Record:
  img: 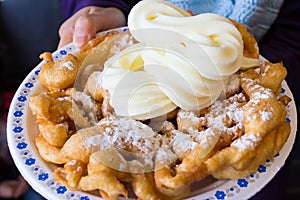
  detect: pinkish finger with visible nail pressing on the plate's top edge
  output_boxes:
[73,15,97,47]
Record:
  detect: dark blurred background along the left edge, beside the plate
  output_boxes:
[0,0,63,200]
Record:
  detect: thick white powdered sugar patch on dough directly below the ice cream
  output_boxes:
[85,118,181,170]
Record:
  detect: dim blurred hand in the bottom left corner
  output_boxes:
[0,176,29,198]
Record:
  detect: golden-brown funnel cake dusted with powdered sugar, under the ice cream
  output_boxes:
[30,12,291,199]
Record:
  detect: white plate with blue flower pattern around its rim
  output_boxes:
[7,27,297,200]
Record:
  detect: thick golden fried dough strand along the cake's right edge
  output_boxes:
[206,62,290,179]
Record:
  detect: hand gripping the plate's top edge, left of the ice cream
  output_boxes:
[58,6,126,48]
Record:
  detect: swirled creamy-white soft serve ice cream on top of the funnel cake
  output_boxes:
[101,0,258,120]
